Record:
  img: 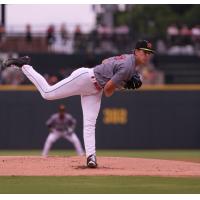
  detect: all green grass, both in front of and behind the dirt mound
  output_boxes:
[0,150,200,194]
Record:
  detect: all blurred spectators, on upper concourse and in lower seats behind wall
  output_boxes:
[0,21,200,85]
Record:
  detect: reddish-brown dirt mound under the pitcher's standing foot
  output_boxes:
[0,156,200,177]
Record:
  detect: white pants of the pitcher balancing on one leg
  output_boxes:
[22,65,103,157]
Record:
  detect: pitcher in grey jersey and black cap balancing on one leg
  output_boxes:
[3,40,154,168]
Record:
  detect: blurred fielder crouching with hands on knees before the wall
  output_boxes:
[42,104,84,156]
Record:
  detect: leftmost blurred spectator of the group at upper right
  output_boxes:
[167,24,179,46]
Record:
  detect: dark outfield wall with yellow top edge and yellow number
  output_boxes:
[0,85,200,149]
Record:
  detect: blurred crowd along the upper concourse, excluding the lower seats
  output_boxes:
[0,24,200,55]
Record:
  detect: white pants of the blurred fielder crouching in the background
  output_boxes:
[42,130,84,156]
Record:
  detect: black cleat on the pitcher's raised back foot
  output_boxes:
[2,56,31,69]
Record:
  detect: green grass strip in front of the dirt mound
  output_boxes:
[0,176,200,194]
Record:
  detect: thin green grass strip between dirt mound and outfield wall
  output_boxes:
[0,149,200,162]
